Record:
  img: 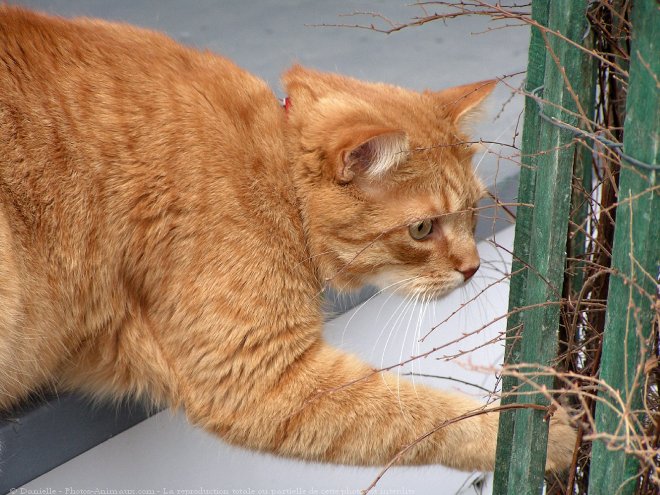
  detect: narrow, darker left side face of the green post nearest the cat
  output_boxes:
[493,0,550,494]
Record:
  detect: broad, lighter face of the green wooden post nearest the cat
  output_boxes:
[507,0,590,495]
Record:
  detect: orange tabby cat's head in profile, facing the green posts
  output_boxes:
[284,67,495,297]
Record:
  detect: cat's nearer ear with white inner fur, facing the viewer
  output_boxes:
[335,126,408,184]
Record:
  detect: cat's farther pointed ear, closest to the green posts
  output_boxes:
[433,79,497,125]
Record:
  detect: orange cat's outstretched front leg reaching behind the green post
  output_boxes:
[178,341,575,470]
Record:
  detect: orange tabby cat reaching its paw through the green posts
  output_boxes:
[0,6,574,470]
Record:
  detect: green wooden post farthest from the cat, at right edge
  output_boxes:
[589,0,660,495]
